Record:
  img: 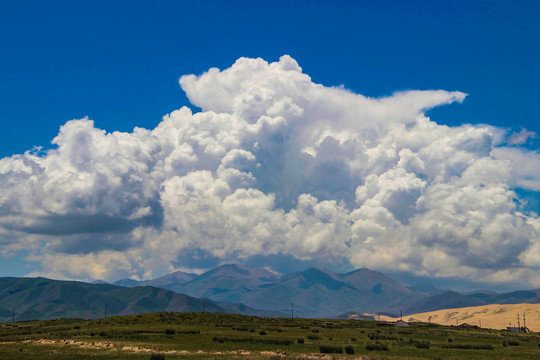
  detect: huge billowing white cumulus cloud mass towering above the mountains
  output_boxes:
[0,56,540,286]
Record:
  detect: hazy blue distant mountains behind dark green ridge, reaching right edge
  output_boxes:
[115,264,540,317]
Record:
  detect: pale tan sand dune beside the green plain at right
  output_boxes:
[381,304,540,332]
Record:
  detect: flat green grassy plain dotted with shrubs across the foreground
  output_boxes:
[0,313,540,360]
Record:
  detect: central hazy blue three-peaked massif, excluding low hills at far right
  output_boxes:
[124,264,425,317]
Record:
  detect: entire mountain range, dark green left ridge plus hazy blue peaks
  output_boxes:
[0,264,540,321]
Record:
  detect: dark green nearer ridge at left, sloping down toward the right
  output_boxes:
[0,278,282,321]
